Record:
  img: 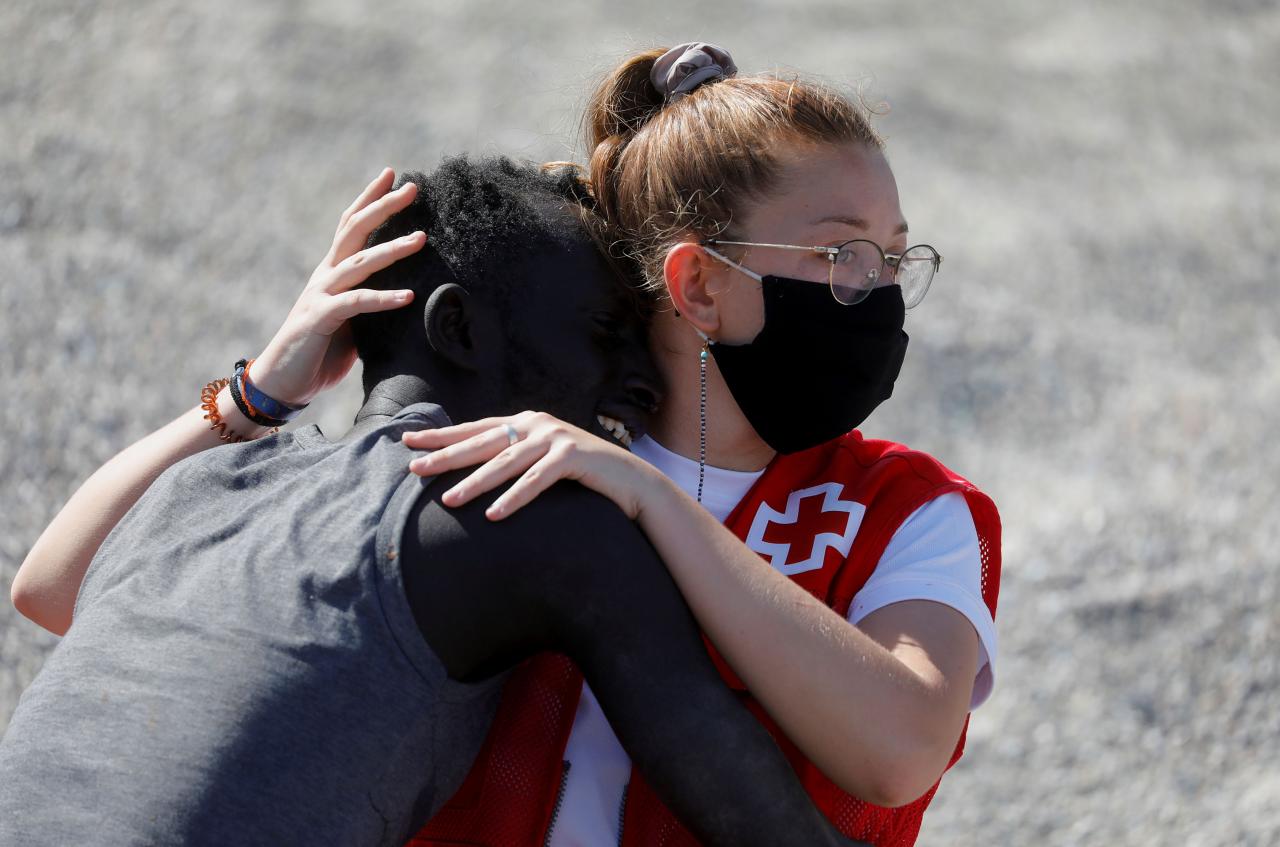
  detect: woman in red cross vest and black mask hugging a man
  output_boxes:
[15,44,1000,844]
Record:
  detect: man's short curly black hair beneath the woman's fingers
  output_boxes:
[352,156,611,368]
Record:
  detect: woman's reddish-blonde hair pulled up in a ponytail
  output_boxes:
[585,49,883,290]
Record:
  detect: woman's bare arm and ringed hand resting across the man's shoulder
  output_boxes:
[404,413,978,806]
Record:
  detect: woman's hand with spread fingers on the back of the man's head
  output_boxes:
[252,168,426,406]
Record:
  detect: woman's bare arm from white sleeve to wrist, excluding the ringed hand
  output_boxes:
[629,479,978,806]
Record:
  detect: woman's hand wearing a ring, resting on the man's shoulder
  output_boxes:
[403,412,666,521]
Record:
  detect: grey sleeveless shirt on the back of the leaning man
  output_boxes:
[0,403,502,846]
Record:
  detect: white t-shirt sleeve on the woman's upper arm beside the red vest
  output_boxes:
[849,493,996,709]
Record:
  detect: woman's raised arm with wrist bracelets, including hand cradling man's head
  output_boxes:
[10,169,426,635]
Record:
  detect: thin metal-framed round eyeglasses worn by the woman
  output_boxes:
[703,238,942,308]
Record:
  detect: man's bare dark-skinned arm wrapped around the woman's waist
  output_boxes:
[403,476,870,846]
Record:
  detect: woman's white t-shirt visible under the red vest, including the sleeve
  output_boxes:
[549,436,996,847]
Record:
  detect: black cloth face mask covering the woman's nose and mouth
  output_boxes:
[710,275,908,453]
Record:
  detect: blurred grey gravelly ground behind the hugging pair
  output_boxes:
[0,0,1280,844]
